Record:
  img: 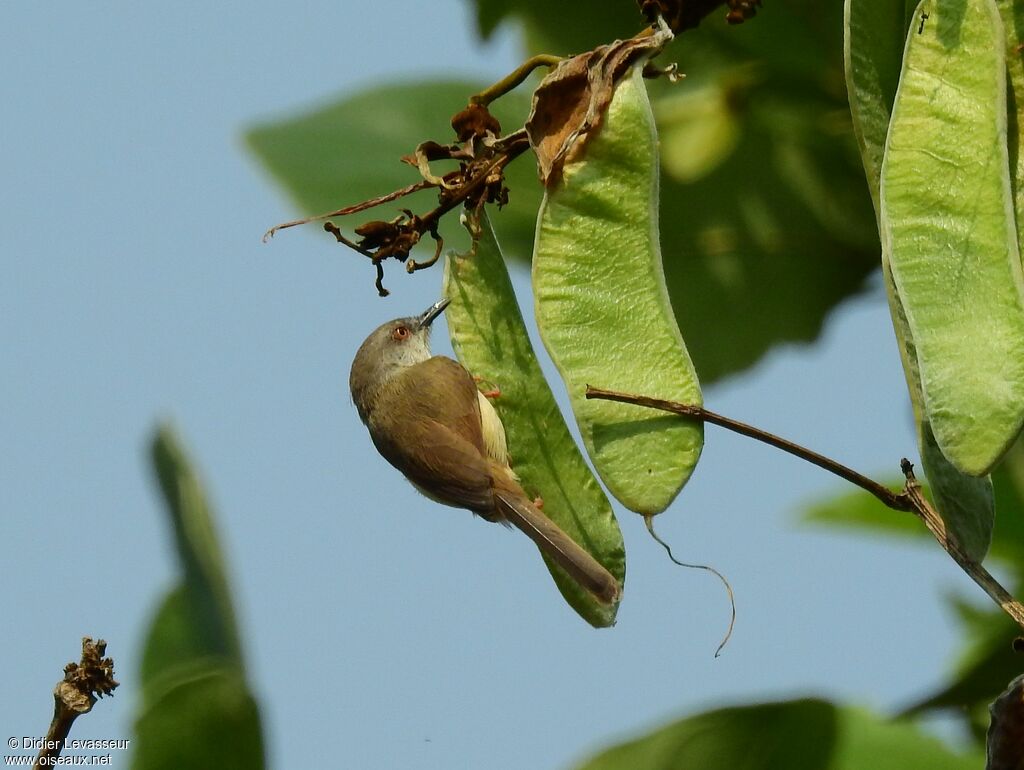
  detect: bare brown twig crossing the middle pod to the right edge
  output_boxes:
[586,385,1024,629]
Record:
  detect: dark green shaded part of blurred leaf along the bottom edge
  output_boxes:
[577,699,838,770]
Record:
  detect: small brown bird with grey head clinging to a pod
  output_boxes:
[349,299,622,604]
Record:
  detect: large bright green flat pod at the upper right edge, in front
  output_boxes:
[880,0,1024,476]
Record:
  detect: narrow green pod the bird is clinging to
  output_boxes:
[443,217,626,628]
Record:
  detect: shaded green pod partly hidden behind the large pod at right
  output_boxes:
[845,0,995,561]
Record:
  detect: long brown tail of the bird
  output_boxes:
[495,489,623,604]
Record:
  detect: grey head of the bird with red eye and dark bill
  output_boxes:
[348,299,451,420]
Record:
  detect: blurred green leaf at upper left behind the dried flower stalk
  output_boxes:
[246,81,541,262]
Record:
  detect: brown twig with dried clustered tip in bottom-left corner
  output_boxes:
[34,637,118,770]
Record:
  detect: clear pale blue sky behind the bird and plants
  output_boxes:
[0,0,976,770]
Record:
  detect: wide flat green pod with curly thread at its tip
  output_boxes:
[534,66,703,515]
